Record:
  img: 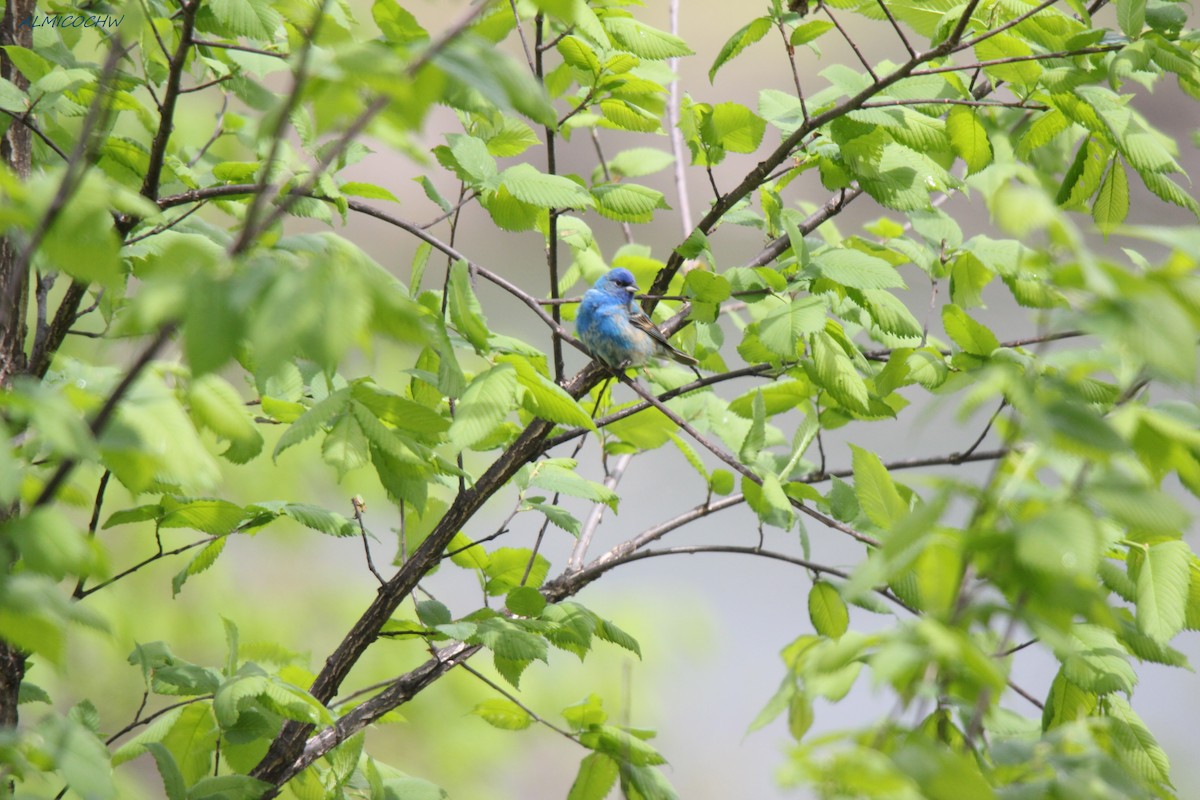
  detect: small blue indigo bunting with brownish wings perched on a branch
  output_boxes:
[575,266,698,369]
